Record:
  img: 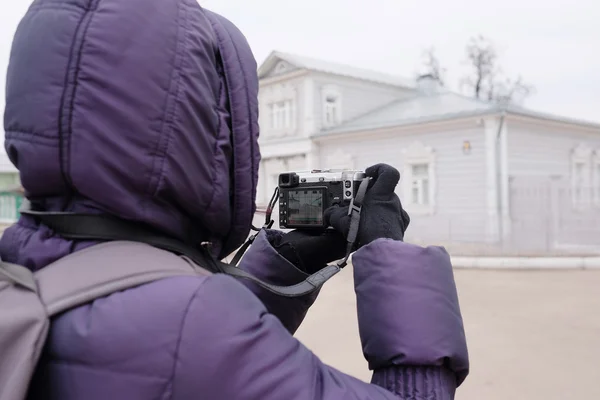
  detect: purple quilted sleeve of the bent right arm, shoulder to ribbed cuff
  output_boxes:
[173,240,468,400]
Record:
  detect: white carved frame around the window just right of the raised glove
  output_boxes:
[402,142,437,215]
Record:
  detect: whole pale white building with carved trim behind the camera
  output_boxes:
[257,52,600,254]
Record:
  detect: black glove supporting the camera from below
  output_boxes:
[271,229,346,274]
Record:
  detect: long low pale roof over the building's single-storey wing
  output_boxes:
[315,91,600,136]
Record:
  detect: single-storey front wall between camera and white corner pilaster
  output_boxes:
[319,119,488,243]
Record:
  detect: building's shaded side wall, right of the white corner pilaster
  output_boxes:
[507,117,600,253]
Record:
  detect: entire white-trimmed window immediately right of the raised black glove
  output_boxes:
[402,142,436,214]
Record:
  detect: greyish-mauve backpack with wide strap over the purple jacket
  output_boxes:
[0,241,210,400]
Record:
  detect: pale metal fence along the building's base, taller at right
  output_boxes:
[407,179,600,256]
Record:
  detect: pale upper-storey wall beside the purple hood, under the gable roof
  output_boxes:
[257,71,412,205]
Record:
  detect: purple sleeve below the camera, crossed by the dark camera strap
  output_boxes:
[239,230,318,334]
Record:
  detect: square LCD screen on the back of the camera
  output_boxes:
[288,189,323,225]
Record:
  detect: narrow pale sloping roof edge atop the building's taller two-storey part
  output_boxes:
[258,51,415,88]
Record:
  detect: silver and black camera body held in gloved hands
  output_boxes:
[278,169,365,229]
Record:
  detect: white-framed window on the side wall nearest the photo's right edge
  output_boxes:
[571,144,592,208]
